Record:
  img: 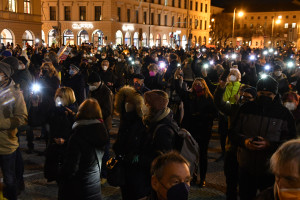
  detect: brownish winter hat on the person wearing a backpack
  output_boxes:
[144,90,169,111]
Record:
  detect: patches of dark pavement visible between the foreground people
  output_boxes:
[19,121,225,200]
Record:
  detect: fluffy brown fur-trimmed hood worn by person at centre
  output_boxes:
[115,85,145,117]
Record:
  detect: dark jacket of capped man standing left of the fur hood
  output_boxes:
[89,82,113,131]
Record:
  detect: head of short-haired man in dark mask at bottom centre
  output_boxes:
[151,151,191,200]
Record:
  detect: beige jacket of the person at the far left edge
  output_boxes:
[0,81,27,155]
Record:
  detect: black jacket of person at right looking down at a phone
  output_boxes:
[230,101,296,175]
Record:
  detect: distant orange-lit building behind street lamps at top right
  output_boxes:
[235,11,300,48]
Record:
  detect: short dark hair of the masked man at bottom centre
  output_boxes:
[151,151,190,180]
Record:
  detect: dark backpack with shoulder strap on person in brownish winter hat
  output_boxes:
[153,124,199,176]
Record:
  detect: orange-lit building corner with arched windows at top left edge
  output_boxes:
[0,0,42,46]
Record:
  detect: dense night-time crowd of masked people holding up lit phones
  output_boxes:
[0,41,300,200]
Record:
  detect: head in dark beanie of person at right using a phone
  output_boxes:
[256,76,278,102]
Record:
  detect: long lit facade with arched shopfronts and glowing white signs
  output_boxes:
[41,0,211,47]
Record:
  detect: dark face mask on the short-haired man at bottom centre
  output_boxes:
[167,183,190,200]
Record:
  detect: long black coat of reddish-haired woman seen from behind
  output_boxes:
[58,120,109,200]
